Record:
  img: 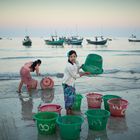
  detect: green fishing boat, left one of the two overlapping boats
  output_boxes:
[44,36,64,45]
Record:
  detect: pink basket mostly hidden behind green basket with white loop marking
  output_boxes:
[38,104,62,114]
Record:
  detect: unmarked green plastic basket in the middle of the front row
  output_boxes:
[56,115,84,140]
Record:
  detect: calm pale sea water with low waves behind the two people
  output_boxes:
[0,38,140,94]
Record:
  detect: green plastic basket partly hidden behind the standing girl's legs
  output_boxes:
[72,94,83,111]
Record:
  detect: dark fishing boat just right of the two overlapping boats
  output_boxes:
[87,36,107,45]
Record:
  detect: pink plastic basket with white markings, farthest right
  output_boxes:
[108,98,128,117]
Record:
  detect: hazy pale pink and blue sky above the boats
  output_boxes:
[0,0,140,36]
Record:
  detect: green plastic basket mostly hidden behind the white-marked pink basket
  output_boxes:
[102,95,121,111]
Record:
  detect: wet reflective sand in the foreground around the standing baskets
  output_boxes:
[0,80,140,140]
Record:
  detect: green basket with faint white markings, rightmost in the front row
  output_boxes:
[85,109,110,131]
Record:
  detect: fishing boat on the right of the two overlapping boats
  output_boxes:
[65,36,83,45]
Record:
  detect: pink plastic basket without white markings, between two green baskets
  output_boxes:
[86,93,102,108]
